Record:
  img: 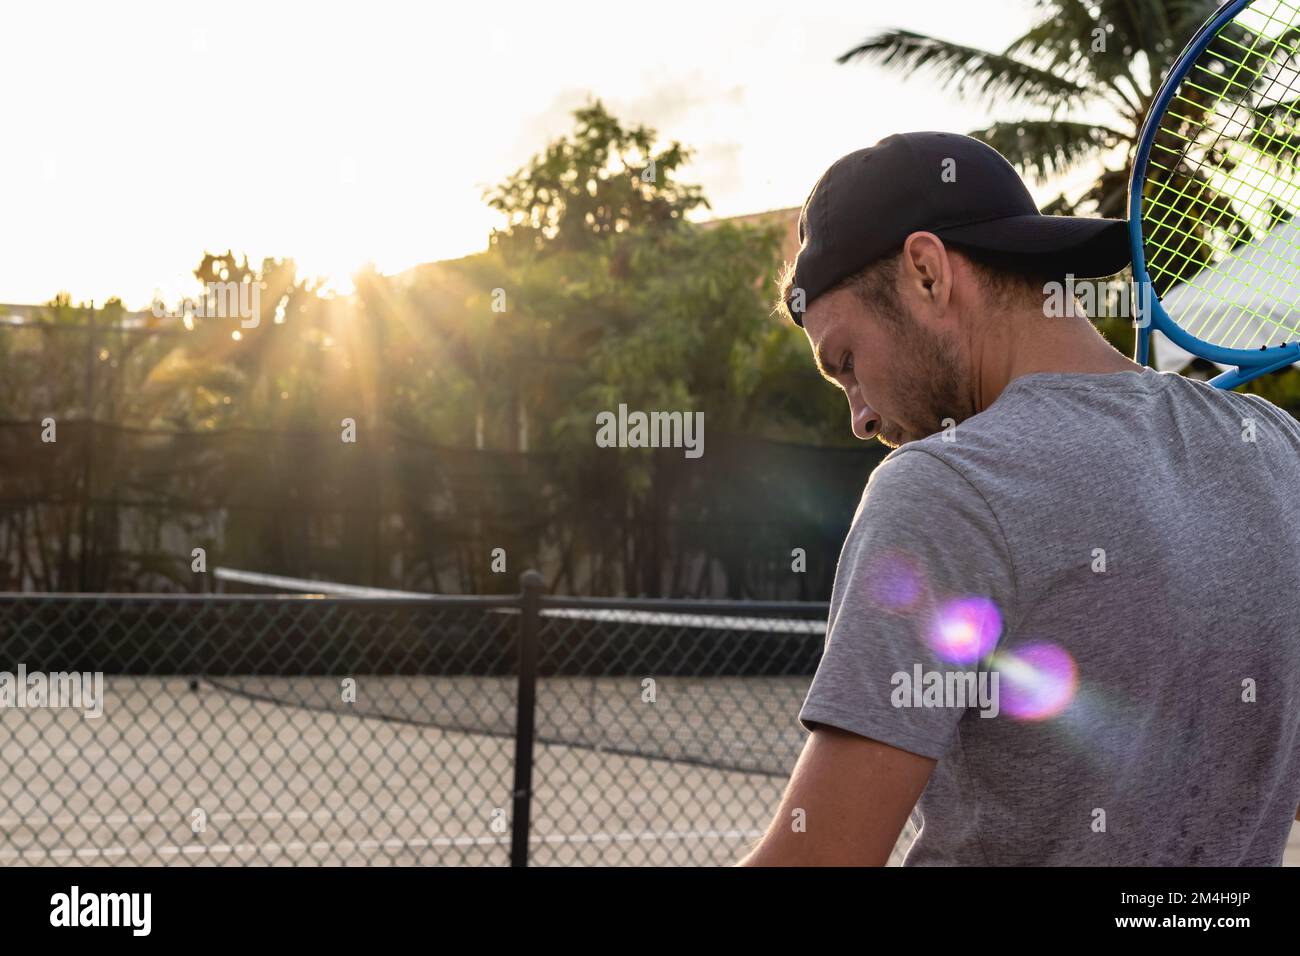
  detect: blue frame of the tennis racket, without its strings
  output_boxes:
[1128,0,1300,389]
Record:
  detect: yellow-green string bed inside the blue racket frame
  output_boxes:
[1143,0,1300,347]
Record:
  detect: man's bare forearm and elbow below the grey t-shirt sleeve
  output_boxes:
[736,726,936,866]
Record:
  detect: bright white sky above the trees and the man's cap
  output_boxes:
[0,0,1076,308]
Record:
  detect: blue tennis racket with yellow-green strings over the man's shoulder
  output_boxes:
[1128,0,1300,389]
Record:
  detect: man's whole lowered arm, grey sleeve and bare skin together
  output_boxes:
[742,446,1018,866]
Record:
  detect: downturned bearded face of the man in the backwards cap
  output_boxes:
[803,289,967,447]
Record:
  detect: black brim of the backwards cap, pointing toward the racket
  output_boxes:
[935,216,1131,278]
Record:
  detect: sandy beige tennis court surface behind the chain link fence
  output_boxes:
[0,678,857,865]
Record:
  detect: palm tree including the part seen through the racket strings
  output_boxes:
[839,0,1300,408]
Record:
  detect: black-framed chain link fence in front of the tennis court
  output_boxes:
[0,574,842,865]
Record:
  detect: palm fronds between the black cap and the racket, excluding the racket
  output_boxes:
[837,0,1218,219]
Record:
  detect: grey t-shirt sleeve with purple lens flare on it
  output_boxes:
[798,446,1015,760]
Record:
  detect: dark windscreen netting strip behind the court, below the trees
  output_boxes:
[0,420,884,600]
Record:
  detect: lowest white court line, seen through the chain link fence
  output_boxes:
[0,830,764,861]
